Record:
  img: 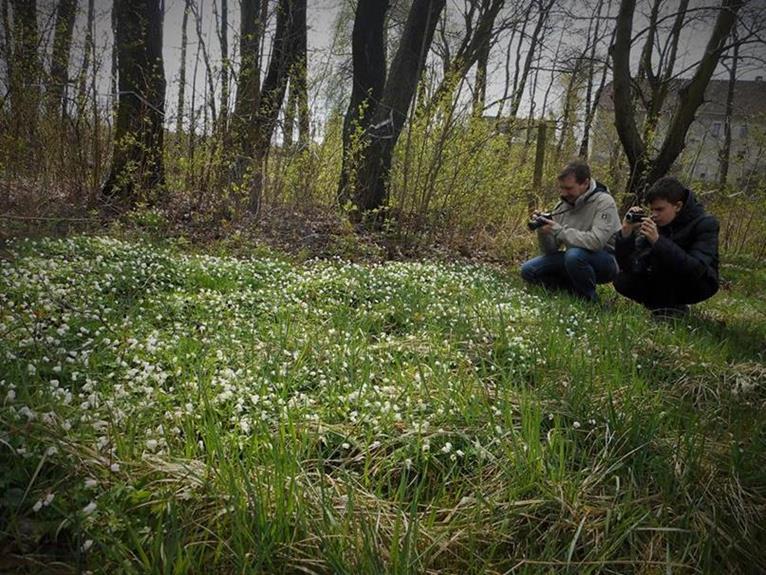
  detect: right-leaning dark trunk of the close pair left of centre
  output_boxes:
[249,0,306,213]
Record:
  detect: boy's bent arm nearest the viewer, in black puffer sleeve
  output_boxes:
[652,217,718,278]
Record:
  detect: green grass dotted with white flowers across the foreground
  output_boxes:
[0,237,766,574]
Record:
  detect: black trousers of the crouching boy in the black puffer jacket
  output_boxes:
[614,271,718,309]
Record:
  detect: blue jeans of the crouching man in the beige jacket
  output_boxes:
[521,248,618,301]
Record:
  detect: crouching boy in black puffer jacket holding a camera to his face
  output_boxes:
[614,177,718,315]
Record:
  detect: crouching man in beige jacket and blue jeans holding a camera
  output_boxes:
[521,160,620,302]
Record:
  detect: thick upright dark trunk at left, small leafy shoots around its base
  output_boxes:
[102,0,165,214]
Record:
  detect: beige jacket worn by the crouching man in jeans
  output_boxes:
[537,178,622,254]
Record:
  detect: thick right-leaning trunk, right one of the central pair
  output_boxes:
[354,0,445,220]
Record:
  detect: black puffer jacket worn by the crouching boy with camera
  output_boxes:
[615,190,718,285]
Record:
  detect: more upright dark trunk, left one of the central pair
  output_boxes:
[338,0,389,205]
